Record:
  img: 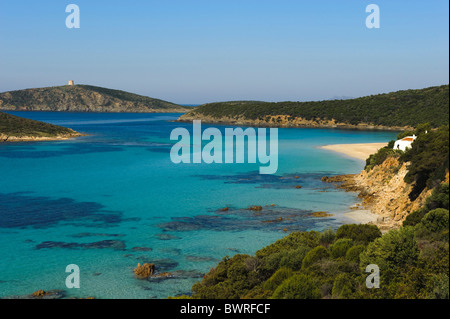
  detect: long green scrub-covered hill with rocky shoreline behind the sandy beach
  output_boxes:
[179,85,449,129]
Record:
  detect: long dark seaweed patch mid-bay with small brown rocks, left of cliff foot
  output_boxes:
[158,207,337,232]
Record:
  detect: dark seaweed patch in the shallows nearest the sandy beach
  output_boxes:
[194,171,338,189]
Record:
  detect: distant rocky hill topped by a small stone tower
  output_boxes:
[0,85,190,113]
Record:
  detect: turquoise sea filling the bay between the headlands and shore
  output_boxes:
[0,112,396,298]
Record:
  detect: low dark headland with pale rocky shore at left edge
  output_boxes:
[0,112,82,143]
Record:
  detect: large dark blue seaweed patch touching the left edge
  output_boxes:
[0,193,122,228]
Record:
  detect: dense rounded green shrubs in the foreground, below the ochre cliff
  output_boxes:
[176,209,449,299]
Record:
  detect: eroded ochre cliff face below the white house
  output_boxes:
[323,157,448,230]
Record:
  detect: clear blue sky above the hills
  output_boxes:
[0,0,449,104]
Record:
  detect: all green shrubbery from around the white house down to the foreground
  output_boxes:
[179,124,449,299]
